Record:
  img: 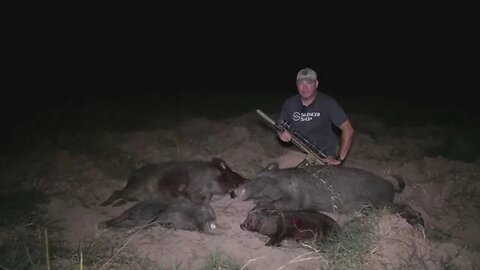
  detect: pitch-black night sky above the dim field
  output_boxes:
[2,8,477,123]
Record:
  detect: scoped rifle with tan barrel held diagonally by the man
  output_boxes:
[257,110,327,168]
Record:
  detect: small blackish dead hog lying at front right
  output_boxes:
[240,208,340,246]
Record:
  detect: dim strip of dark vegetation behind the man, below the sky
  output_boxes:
[2,90,480,161]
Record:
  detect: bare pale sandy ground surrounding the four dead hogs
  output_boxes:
[41,114,480,270]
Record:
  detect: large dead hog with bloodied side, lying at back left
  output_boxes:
[101,158,247,206]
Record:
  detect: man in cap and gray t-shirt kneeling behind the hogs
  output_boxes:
[278,68,354,167]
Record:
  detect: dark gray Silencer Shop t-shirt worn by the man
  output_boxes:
[279,92,348,156]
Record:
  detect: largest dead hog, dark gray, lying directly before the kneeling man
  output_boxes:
[240,165,423,225]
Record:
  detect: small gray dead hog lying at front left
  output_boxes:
[98,198,216,233]
